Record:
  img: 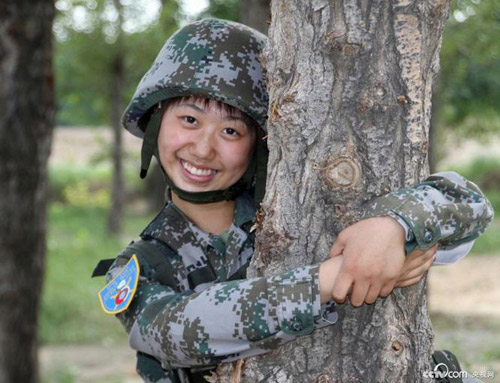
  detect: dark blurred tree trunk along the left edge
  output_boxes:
[0,0,54,383]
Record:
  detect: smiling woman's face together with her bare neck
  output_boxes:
[158,97,258,234]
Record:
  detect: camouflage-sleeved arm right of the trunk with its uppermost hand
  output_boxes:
[330,172,493,306]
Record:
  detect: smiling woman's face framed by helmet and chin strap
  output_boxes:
[158,97,256,192]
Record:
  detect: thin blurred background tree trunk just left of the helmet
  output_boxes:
[108,0,124,234]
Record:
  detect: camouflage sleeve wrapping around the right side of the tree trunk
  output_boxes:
[364,172,493,263]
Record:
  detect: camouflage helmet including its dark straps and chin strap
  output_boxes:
[126,19,268,203]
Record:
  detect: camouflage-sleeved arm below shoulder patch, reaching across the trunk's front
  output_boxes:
[110,250,341,367]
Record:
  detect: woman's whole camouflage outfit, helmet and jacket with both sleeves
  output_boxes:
[98,20,492,383]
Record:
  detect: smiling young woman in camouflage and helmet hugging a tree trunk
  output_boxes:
[94,19,496,383]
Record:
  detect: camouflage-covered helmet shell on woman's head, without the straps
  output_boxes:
[122,19,268,137]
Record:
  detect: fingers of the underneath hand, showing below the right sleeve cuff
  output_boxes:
[394,244,438,287]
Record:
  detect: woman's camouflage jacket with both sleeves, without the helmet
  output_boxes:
[108,173,493,383]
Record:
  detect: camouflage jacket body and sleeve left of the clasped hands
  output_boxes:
[107,194,337,382]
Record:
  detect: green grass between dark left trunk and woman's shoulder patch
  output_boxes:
[40,204,150,344]
